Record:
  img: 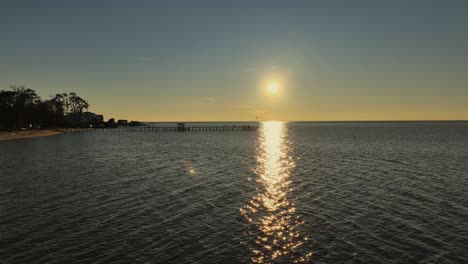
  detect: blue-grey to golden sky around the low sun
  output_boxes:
[0,0,468,121]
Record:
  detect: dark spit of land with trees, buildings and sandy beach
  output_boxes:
[0,85,140,135]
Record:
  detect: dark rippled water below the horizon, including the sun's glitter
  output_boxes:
[0,123,468,263]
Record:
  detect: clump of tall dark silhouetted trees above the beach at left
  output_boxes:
[0,85,89,129]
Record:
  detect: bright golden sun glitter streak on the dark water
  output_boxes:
[240,122,312,263]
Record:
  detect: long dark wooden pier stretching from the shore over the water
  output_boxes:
[94,123,258,132]
